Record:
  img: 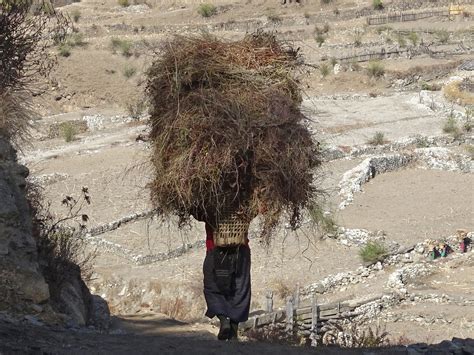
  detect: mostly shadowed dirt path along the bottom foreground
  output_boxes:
[0,316,474,355]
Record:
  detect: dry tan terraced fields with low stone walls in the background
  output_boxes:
[0,0,474,354]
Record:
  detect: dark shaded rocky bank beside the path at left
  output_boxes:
[0,137,109,328]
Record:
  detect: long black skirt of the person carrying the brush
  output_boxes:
[203,246,251,322]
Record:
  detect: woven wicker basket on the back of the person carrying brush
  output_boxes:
[214,212,250,247]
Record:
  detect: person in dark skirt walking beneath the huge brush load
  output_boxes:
[194,211,251,340]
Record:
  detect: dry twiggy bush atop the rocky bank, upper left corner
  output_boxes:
[0,0,68,142]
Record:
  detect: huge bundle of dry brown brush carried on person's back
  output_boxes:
[147,33,320,242]
